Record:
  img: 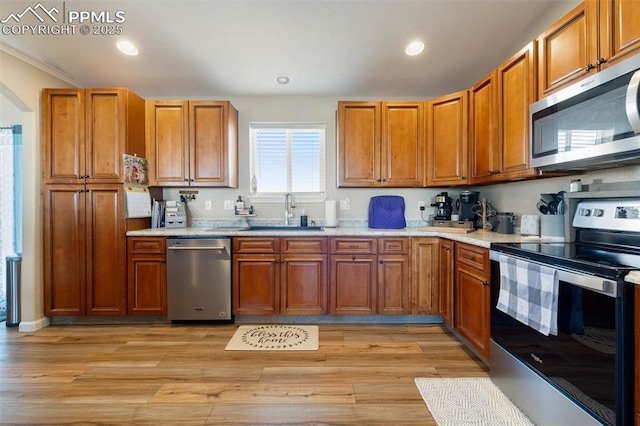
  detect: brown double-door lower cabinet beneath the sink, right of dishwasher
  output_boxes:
[233,237,328,315]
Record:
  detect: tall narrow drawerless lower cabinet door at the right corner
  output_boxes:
[411,237,438,315]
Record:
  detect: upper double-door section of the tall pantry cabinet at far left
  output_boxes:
[42,88,145,184]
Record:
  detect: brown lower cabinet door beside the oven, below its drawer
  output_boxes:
[454,266,490,358]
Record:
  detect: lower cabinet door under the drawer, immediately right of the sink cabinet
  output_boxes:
[329,254,377,315]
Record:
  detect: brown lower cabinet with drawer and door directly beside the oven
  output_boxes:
[453,243,491,359]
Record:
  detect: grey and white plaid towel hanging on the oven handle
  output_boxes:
[496,255,559,336]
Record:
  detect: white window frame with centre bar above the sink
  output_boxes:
[249,122,327,203]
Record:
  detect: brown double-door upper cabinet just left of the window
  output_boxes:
[147,101,238,188]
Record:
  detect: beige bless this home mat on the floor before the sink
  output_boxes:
[225,325,318,351]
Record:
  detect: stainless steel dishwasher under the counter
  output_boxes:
[167,237,232,321]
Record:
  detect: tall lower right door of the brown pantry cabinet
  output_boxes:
[86,185,127,315]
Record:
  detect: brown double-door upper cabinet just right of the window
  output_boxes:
[338,101,424,187]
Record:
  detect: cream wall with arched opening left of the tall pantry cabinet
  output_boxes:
[0,51,70,331]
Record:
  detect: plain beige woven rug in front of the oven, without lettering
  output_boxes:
[415,378,533,426]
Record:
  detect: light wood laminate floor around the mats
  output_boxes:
[0,324,488,425]
